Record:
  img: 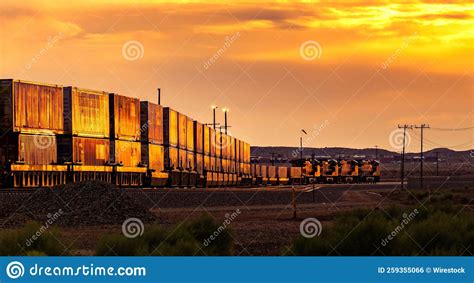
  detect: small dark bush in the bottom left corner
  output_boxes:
[0,222,67,256]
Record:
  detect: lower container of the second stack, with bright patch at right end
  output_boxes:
[57,136,110,166]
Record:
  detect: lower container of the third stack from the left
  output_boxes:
[110,140,141,167]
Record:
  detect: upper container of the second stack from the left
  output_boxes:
[64,87,110,138]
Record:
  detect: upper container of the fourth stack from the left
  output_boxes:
[140,101,163,145]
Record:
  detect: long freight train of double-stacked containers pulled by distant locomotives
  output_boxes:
[0,79,380,188]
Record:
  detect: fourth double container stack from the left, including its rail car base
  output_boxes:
[140,101,168,187]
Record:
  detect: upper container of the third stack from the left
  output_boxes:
[109,93,140,141]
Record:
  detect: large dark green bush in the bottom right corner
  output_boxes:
[286,206,474,256]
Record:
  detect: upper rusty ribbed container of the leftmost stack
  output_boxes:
[0,79,64,135]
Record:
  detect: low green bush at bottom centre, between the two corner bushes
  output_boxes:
[96,215,233,256]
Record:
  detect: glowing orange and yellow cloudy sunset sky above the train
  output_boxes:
[0,0,474,151]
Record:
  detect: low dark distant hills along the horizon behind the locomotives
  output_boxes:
[251,146,474,162]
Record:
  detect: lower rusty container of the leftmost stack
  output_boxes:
[0,133,58,165]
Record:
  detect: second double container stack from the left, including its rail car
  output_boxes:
[58,87,112,182]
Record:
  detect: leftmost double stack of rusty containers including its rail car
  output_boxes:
[0,79,66,187]
